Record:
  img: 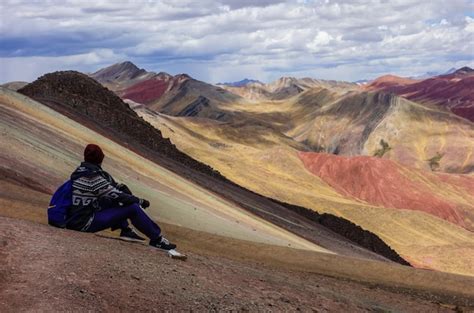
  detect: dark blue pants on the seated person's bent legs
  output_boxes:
[87,204,161,240]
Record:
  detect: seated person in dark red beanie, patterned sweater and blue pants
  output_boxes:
[66,144,176,250]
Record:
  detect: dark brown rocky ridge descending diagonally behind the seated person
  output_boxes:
[13,72,406,264]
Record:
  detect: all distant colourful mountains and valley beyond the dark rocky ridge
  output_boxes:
[83,61,474,273]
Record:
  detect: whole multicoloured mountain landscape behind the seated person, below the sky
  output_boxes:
[0,62,474,305]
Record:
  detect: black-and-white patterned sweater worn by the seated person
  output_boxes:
[67,162,140,231]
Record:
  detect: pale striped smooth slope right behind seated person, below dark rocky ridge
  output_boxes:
[0,88,325,251]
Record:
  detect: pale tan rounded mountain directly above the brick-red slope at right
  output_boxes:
[287,92,474,173]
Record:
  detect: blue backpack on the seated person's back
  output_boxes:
[48,180,72,228]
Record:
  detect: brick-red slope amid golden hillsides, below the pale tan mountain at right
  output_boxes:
[299,152,474,229]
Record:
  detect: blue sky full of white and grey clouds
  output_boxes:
[0,0,474,83]
